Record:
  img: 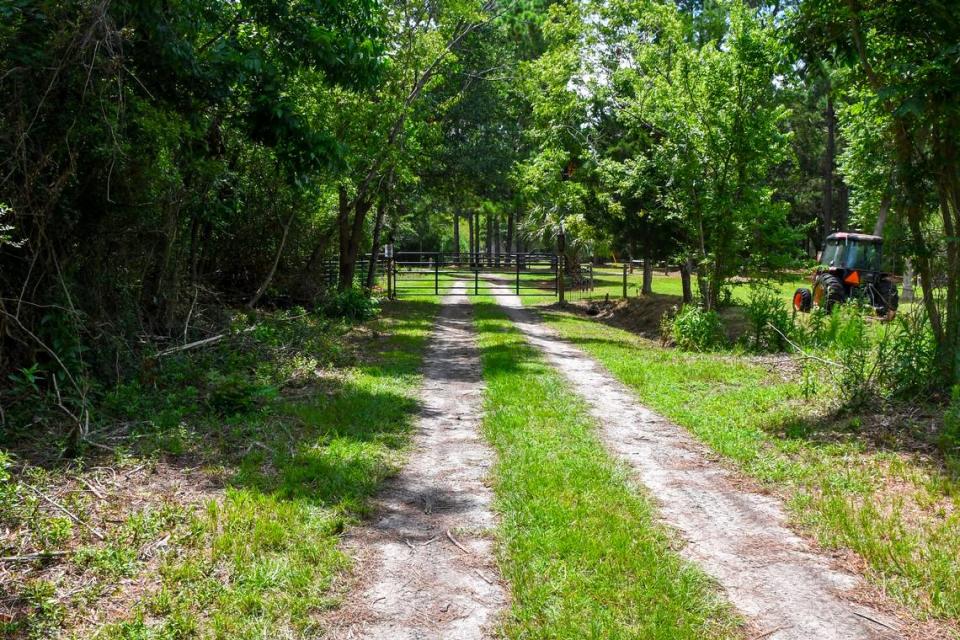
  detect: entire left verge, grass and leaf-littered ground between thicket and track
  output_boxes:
[0,301,437,639]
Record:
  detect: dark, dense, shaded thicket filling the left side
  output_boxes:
[0,0,383,440]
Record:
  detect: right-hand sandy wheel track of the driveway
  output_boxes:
[497,292,908,640]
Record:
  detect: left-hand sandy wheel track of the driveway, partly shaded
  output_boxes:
[324,283,507,640]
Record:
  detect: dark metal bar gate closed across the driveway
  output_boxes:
[387,251,558,297]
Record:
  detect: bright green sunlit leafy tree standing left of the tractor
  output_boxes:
[604,2,796,309]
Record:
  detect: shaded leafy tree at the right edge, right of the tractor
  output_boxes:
[794,0,960,381]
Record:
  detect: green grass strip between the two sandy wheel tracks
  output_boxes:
[475,302,738,640]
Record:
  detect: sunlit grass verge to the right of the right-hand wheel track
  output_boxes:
[541,310,960,622]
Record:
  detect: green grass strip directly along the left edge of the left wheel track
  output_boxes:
[93,302,436,639]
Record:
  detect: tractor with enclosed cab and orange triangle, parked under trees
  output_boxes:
[793,233,900,320]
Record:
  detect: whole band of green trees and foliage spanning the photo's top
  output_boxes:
[0,0,960,416]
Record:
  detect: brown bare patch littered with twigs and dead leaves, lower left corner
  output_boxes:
[0,461,222,637]
